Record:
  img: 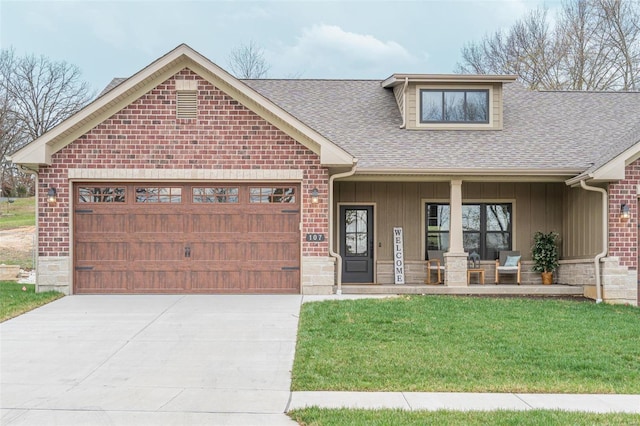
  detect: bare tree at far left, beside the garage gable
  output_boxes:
[0,49,93,196]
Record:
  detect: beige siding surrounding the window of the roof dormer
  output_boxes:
[404,83,502,130]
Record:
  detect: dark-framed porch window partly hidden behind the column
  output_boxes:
[425,203,512,260]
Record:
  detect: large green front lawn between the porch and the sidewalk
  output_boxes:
[292,296,640,394]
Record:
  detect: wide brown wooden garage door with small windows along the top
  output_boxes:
[73,183,300,294]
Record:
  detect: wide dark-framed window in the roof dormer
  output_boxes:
[420,89,489,123]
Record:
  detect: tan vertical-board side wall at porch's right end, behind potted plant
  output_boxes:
[562,188,602,259]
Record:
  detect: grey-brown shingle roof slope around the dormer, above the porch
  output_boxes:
[244,80,640,174]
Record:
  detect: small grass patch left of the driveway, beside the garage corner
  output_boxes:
[0,281,63,322]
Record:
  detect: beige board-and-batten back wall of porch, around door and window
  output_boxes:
[334,182,566,262]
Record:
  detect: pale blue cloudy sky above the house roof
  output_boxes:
[0,0,560,91]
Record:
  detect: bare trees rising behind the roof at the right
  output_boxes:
[457,0,640,90]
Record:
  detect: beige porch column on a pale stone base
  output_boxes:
[444,180,467,287]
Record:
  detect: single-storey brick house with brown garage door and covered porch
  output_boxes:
[12,45,640,305]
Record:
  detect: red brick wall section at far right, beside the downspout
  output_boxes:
[609,160,640,269]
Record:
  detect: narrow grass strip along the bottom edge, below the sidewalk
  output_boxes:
[287,407,640,426]
